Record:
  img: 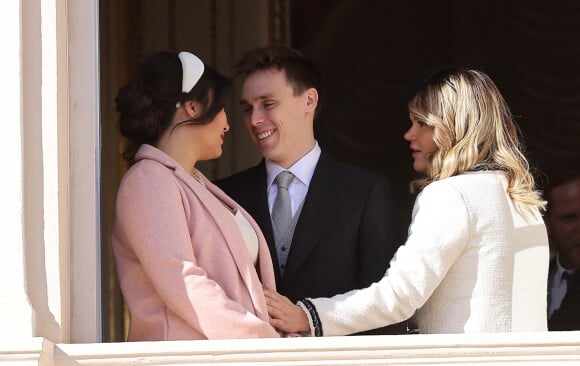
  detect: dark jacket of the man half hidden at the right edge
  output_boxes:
[548,258,580,331]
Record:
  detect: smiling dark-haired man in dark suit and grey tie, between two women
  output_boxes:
[216,47,406,334]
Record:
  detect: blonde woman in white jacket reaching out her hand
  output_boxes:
[266,69,549,336]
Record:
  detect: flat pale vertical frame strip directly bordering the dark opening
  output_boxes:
[65,0,101,343]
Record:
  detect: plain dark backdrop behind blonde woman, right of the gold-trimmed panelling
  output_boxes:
[291,0,580,229]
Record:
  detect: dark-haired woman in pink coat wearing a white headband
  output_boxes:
[113,52,279,341]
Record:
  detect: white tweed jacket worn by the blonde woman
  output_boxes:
[310,171,549,336]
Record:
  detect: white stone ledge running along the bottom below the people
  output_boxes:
[49,332,580,366]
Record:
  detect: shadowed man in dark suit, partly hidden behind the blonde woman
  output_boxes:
[545,159,580,330]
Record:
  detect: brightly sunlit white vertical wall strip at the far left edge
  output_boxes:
[0,1,33,343]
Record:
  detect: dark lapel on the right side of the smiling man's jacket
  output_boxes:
[284,152,348,278]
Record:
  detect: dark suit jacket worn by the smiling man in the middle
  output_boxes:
[216,151,401,334]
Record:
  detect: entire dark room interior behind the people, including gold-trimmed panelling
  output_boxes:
[99,0,580,341]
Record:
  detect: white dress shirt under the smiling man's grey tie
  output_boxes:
[266,142,321,217]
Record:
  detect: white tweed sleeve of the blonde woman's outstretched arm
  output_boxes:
[311,183,469,336]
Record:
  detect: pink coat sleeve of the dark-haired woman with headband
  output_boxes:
[117,164,278,339]
